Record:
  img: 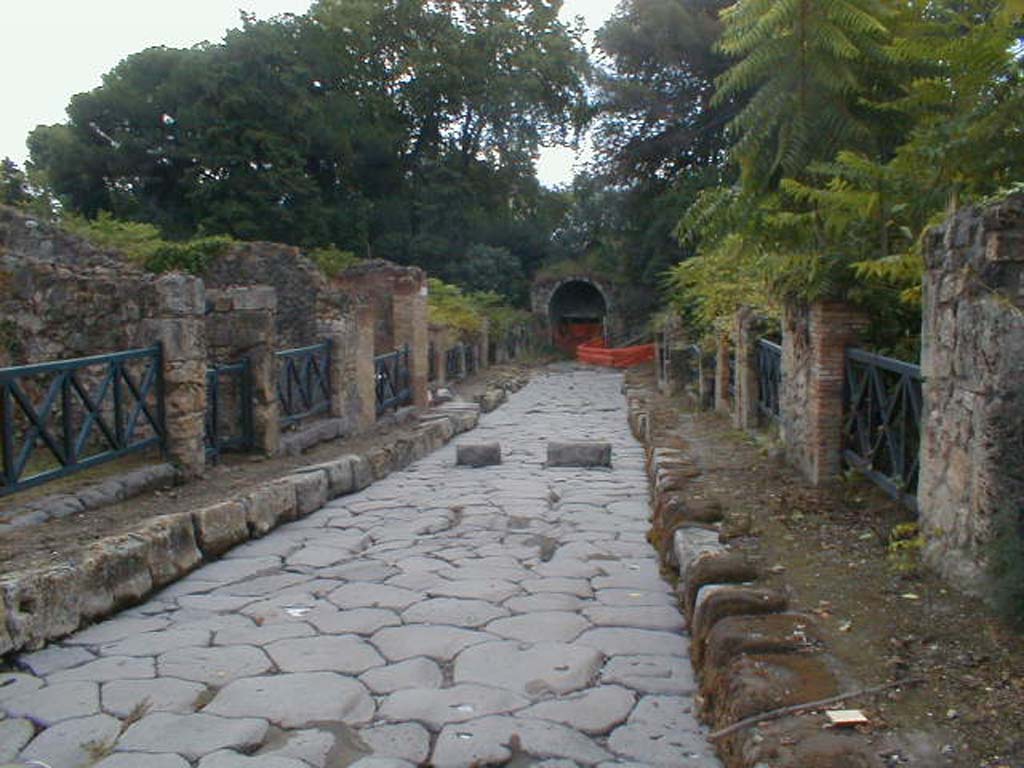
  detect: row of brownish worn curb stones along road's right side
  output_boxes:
[623,372,882,768]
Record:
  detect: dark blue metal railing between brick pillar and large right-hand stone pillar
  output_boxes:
[843,349,922,507]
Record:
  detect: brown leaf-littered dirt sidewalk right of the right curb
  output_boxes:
[656,380,1024,768]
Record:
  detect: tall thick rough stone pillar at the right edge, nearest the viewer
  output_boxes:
[918,195,1024,591]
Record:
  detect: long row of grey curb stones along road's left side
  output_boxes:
[0,402,497,656]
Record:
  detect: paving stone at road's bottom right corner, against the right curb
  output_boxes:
[608,696,721,768]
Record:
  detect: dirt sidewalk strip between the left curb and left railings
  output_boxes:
[0,366,522,575]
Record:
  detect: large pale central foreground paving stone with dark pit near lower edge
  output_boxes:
[455,640,604,696]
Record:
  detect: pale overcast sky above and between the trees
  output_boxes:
[0,0,617,185]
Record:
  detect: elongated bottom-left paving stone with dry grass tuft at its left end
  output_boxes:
[118,712,267,760]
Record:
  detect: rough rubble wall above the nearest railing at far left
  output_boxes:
[0,207,159,367]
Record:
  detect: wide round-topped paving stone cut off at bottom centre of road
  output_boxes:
[431,716,610,768]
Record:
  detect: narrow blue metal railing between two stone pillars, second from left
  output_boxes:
[204,357,253,461]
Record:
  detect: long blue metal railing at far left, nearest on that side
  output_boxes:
[0,345,165,496]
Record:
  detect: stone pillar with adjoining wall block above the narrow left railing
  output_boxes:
[206,286,281,456]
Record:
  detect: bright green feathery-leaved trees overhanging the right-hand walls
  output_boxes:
[668,0,1024,357]
